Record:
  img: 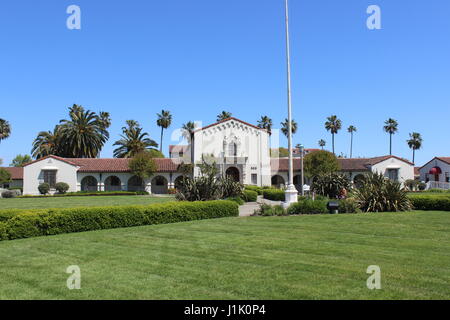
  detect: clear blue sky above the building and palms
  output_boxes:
[0,0,450,165]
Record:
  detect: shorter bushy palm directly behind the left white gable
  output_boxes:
[31,126,66,159]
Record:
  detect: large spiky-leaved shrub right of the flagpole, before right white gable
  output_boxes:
[354,173,412,212]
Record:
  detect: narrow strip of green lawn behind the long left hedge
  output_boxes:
[0,196,174,209]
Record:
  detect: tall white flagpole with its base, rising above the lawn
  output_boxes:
[285,0,298,207]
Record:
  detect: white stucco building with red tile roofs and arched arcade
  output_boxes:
[19,118,414,195]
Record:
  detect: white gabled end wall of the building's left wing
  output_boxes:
[23,158,78,195]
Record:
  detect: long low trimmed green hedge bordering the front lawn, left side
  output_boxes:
[0,200,239,240]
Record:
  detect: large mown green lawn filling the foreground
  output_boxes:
[0,212,450,299]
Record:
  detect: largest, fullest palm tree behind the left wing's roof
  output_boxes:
[60,105,109,158]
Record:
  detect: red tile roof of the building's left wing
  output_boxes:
[23,156,180,172]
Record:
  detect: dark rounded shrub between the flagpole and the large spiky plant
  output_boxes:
[311,173,350,199]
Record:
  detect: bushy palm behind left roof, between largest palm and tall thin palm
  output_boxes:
[114,120,158,158]
